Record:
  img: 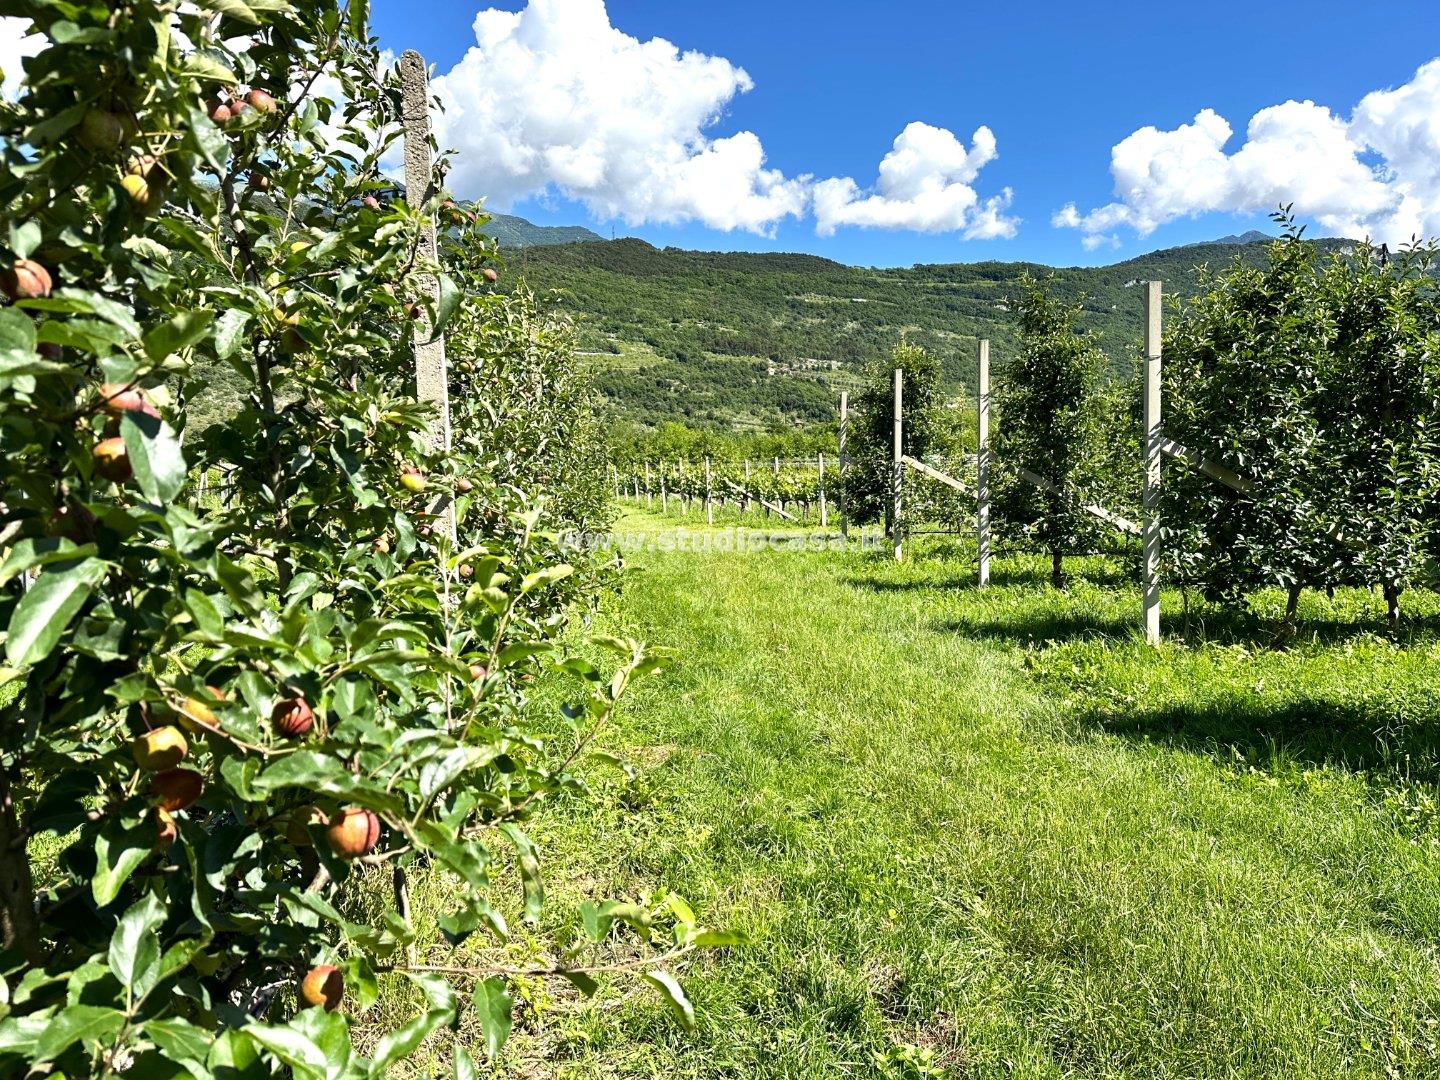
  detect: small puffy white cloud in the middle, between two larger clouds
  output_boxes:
[815,122,1018,239]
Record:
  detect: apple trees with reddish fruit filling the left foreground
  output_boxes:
[0,0,726,1077]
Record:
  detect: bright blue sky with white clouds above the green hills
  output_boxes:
[373,0,1440,265]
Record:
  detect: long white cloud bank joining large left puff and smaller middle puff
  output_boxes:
[420,0,1015,238]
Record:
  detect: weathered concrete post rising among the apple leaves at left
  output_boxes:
[400,49,455,546]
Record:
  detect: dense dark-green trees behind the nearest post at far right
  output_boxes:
[1164,217,1440,624]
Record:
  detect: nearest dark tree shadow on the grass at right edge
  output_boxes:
[1076,698,1440,783]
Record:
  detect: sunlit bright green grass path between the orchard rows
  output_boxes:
[514,521,1440,1079]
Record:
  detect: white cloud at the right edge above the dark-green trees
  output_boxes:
[1051,60,1440,248]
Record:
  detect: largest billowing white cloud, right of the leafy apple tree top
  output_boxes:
[433,0,809,233]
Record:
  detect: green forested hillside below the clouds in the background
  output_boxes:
[510,236,1341,426]
